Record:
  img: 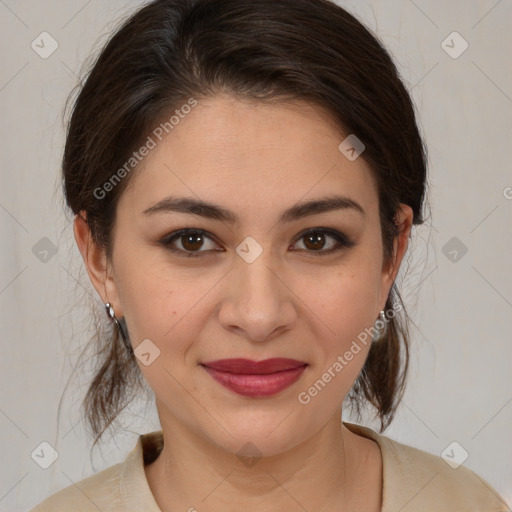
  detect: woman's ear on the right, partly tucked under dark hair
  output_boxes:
[380,203,414,310]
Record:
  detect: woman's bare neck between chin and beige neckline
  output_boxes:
[145,411,378,512]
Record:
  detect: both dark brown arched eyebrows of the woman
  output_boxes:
[142,195,366,224]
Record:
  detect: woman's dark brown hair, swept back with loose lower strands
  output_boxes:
[63,0,426,443]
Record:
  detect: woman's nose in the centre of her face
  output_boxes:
[218,255,297,342]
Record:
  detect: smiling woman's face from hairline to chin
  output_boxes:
[83,96,412,455]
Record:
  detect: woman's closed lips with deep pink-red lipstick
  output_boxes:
[201,358,308,398]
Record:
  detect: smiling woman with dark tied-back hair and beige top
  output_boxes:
[34,0,508,512]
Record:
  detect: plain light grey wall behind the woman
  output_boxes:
[0,0,512,511]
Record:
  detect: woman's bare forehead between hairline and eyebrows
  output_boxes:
[120,96,377,218]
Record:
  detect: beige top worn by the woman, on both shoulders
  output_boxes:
[30,422,511,512]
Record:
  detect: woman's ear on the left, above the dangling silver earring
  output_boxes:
[73,210,122,318]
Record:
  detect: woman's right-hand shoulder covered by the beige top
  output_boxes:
[345,423,510,512]
